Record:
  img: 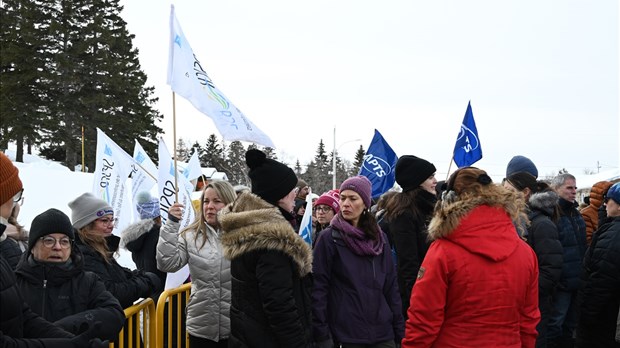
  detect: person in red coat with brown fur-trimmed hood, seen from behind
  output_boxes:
[402,167,540,348]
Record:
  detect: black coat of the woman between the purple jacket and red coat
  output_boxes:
[382,189,437,319]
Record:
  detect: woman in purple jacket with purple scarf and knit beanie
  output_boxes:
[312,176,404,348]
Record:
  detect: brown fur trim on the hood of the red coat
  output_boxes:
[428,184,528,240]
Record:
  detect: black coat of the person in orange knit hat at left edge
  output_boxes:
[0,238,73,348]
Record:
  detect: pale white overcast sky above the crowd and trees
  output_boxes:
[118,0,620,185]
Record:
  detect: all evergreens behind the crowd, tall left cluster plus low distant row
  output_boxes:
[0,0,364,194]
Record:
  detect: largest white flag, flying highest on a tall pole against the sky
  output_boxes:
[167,5,275,148]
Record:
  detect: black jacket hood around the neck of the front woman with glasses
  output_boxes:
[15,245,84,285]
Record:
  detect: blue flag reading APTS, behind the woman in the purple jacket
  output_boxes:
[358,129,398,198]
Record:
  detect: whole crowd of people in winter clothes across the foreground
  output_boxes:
[0,149,620,348]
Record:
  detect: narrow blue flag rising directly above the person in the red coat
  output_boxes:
[453,102,482,168]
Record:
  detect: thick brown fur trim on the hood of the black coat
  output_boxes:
[218,192,312,277]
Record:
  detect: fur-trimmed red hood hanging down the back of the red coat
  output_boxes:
[428,194,525,262]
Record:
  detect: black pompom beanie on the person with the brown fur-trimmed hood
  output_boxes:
[245,149,297,205]
